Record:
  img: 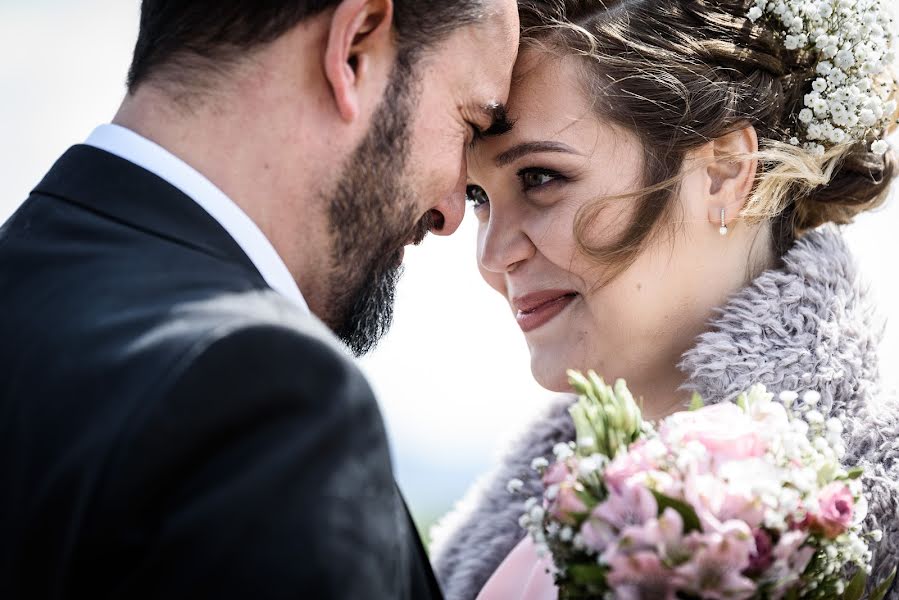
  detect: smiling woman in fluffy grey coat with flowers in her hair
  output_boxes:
[434,0,899,600]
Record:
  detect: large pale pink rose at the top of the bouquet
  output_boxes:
[659,403,766,462]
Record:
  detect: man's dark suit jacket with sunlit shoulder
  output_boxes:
[0,146,440,600]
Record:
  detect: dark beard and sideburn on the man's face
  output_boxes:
[324,59,432,356]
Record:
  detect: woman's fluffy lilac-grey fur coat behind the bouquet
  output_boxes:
[433,228,899,600]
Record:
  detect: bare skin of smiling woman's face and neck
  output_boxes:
[467,51,760,391]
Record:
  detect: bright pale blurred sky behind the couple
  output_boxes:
[0,0,899,536]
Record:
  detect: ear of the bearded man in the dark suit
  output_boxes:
[324,0,394,122]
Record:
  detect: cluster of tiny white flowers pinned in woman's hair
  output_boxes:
[749,0,897,156]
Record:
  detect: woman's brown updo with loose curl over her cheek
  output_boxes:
[519,0,896,272]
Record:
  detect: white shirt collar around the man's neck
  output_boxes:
[85,125,309,312]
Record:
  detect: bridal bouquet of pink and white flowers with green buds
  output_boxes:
[510,372,895,600]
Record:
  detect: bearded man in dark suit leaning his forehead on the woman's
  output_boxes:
[0,0,518,600]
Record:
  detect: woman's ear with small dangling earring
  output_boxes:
[704,125,759,225]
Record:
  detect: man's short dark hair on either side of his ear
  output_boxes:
[128,0,483,93]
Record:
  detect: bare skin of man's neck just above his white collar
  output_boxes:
[113,87,330,312]
